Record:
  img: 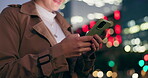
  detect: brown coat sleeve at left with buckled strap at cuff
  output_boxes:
[0,7,68,78]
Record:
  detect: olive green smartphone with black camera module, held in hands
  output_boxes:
[86,19,112,36]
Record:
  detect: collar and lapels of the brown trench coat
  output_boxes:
[20,0,70,46]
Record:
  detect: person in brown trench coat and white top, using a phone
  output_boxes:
[0,0,102,78]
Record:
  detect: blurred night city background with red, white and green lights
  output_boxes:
[0,0,148,78]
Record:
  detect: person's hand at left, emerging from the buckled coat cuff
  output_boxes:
[53,34,93,58]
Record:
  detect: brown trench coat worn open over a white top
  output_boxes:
[0,1,95,78]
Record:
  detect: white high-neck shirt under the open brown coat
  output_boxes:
[35,4,65,43]
